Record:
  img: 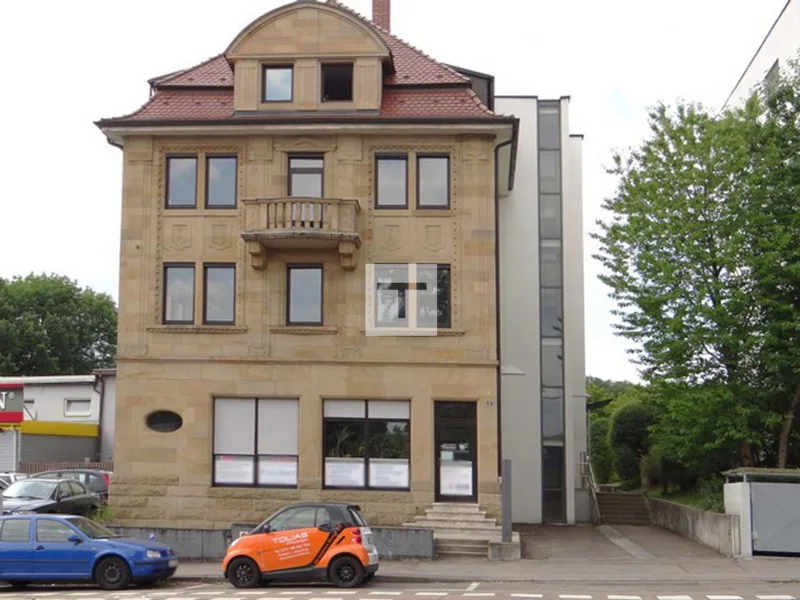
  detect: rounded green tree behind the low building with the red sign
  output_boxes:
[0,274,117,376]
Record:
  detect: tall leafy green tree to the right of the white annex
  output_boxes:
[595,51,800,476]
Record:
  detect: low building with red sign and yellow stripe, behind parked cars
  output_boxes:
[0,369,116,471]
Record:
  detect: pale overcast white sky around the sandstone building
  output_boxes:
[0,0,785,381]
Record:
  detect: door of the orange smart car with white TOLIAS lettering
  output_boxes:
[260,506,330,571]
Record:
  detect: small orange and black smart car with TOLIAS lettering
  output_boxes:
[222,502,378,588]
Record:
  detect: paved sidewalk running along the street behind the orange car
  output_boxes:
[175,557,800,584]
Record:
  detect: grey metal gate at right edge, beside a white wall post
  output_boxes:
[750,482,800,553]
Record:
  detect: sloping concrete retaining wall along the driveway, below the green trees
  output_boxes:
[648,498,741,556]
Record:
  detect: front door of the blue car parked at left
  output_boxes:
[33,517,94,579]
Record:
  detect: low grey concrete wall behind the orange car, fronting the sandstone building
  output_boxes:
[109,523,436,560]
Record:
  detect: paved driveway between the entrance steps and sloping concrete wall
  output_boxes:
[514,524,722,561]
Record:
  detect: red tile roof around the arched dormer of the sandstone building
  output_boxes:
[101,0,506,123]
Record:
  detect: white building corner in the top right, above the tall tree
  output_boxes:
[724,0,800,108]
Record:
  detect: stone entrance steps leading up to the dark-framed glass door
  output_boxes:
[403,502,519,558]
